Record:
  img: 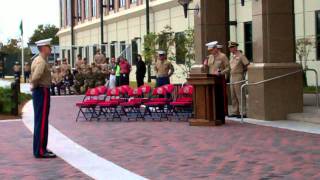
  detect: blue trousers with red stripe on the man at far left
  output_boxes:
[32,87,50,157]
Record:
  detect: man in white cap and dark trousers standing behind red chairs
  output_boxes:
[154,51,174,87]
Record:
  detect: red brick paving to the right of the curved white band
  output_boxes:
[50,97,320,180]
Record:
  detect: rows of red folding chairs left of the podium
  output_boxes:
[76,84,193,121]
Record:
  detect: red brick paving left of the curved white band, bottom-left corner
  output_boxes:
[0,122,90,179]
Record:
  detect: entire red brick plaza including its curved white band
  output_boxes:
[0,96,320,180]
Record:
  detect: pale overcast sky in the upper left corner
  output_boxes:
[0,0,59,44]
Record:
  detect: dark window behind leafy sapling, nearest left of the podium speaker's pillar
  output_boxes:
[175,32,187,64]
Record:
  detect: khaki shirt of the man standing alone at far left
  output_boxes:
[30,55,51,88]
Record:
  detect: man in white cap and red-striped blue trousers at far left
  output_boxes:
[30,39,56,158]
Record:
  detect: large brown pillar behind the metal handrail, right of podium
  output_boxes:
[248,0,303,120]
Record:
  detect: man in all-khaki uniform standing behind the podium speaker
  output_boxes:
[228,41,250,118]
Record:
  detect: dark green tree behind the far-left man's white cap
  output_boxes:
[29,24,59,45]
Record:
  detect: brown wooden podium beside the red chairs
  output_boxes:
[187,73,225,126]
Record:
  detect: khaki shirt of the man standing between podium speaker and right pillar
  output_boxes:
[230,52,250,74]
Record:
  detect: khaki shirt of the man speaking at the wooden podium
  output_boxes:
[208,53,230,75]
